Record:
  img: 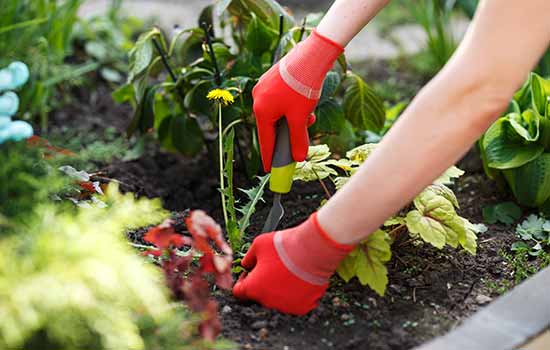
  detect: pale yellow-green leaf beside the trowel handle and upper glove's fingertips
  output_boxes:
[294,145,338,182]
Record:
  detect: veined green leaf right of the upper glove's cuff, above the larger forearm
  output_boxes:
[344,73,386,132]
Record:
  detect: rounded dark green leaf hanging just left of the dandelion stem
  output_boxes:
[170,116,203,156]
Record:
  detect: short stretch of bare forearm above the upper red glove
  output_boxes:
[317,0,390,47]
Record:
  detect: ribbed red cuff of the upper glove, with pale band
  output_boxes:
[279,30,344,100]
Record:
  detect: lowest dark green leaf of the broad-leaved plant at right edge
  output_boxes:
[504,153,550,207]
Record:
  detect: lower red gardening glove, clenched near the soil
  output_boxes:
[233,213,354,315]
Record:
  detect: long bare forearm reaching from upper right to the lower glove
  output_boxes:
[319,0,550,243]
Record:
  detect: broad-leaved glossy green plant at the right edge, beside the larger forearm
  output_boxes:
[478,73,550,212]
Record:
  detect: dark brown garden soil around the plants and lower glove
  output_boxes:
[51,69,528,350]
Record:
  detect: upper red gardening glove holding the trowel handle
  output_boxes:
[252,31,344,172]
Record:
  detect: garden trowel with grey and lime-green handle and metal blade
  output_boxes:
[262,116,296,232]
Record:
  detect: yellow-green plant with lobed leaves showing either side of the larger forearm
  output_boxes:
[295,144,484,295]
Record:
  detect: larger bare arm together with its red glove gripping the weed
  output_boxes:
[234,0,550,314]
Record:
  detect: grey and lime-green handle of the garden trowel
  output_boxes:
[269,117,296,193]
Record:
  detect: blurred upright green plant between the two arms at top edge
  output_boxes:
[407,0,458,72]
